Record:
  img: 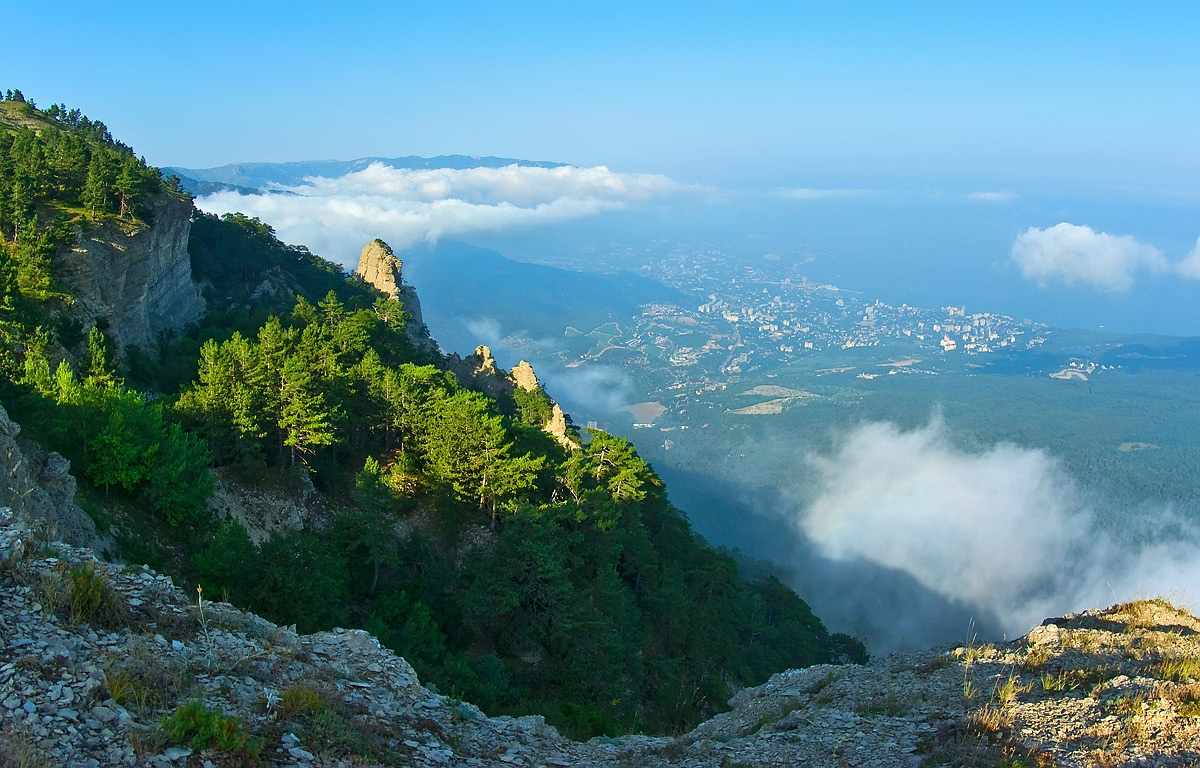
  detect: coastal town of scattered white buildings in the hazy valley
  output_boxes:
[552,244,1048,377]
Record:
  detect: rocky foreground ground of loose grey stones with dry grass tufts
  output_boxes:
[0,509,1200,768]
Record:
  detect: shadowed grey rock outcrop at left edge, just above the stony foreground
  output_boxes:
[0,407,102,548]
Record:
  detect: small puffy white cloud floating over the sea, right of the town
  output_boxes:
[1010,222,1170,292]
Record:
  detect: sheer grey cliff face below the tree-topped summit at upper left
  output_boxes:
[55,193,204,346]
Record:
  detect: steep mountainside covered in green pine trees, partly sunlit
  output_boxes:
[0,90,864,736]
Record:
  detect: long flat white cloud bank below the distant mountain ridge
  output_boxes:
[196,163,683,266]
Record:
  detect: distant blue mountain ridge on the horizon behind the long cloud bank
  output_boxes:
[162,155,568,194]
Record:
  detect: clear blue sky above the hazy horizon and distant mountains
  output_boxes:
[9,1,1200,192]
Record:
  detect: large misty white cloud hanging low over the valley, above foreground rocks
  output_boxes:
[794,418,1200,637]
